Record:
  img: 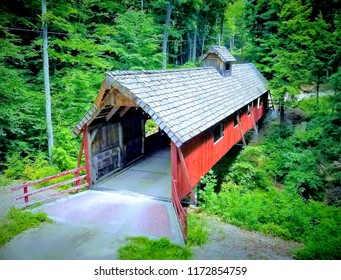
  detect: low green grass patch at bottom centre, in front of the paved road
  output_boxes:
[118,237,191,260]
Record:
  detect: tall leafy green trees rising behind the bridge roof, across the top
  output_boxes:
[0,0,340,178]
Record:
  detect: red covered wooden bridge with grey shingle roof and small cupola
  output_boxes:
[73,46,268,241]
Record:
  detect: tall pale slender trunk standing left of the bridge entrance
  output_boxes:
[41,0,54,164]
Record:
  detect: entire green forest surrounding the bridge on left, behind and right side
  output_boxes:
[0,0,341,259]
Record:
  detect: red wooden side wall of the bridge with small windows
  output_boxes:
[171,94,267,200]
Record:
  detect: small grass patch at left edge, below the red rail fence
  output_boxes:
[0,208,52,246]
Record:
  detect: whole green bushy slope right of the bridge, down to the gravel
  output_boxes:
[200,96,341,259]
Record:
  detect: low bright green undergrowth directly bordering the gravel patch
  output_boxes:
[202,171,341,259]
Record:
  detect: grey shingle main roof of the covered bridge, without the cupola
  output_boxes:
[73,64,268,147]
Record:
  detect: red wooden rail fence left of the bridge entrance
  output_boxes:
[11,166,89,207]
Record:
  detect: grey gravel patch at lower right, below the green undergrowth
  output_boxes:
[192,212,300,260]
